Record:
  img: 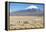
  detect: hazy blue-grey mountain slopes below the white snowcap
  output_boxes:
[10,8,44,16]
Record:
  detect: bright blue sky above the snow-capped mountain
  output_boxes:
[10,3,44,12]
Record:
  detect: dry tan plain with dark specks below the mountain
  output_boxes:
[10,16,43,30]
